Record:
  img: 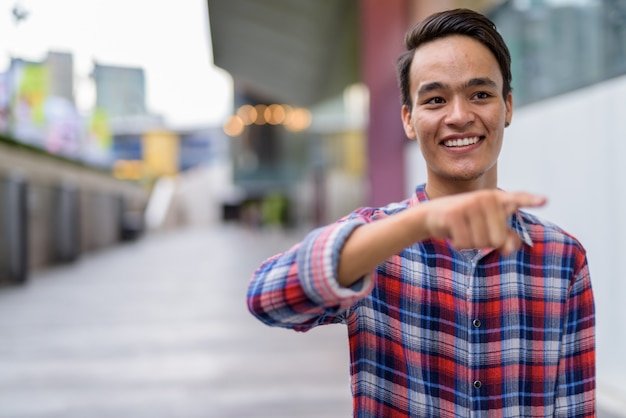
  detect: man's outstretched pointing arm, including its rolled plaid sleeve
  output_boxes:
[248,190,545,331]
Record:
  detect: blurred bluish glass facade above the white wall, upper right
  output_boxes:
[488,0,626,106]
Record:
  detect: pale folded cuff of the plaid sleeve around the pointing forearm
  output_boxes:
[297,220,373,311]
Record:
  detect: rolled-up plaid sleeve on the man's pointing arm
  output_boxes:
[247,219,373,331]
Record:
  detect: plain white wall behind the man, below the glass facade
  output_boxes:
[406,77,626,409]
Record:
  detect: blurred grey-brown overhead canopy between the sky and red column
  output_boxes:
[207,0,359,106]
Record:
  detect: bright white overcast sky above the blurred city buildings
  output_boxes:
[0,0,232,127]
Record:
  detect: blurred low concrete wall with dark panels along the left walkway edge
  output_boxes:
[0,141,148,283]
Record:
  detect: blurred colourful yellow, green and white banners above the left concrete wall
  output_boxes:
[0,53,120,169]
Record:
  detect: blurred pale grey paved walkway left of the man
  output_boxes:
[0,225,617,418]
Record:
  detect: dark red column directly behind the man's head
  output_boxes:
[359,0,410,206]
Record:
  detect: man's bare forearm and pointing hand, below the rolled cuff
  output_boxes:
[338,190,546,287]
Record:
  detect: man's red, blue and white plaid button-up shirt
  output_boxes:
[248,185,595,418]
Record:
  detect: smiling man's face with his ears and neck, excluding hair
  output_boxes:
[402,35,513,197]
